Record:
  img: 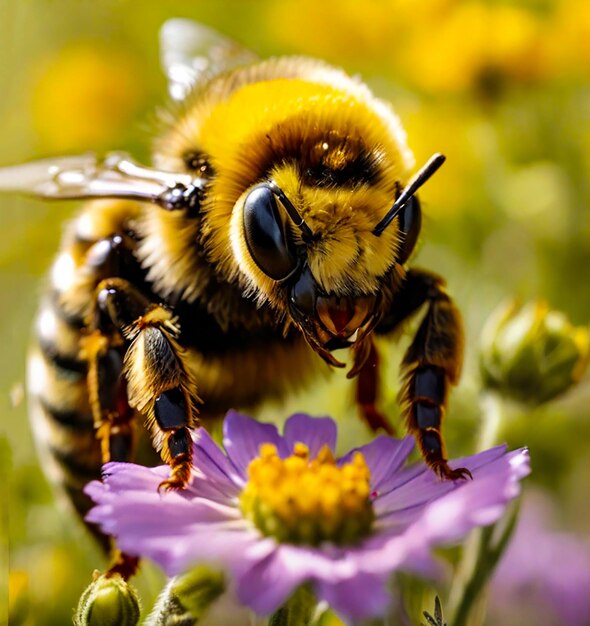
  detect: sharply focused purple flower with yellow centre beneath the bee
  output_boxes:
[86,412,529,620]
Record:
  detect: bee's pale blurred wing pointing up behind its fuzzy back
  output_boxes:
[160,18,256,101]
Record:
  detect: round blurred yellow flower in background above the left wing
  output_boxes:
[31,43,144,152]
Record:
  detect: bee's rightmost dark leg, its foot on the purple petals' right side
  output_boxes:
[378,270,470,480]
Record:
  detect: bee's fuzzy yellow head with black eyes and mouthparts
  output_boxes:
[232,153,442,365]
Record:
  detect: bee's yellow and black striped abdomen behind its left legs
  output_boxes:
[27,201,143,528]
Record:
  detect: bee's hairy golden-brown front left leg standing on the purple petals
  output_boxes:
[96,278,199,489]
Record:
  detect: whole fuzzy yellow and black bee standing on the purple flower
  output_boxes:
[0,20,469,560]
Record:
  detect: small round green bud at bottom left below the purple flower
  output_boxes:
[74,574,140,626]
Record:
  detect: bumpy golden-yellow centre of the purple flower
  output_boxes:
[240,443,374,545]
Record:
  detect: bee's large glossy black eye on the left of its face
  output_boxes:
[244,185,297,280]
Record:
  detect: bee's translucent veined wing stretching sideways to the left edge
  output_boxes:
[0,152,204,210]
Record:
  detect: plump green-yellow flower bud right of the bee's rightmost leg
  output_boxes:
[480,302,590,405]
